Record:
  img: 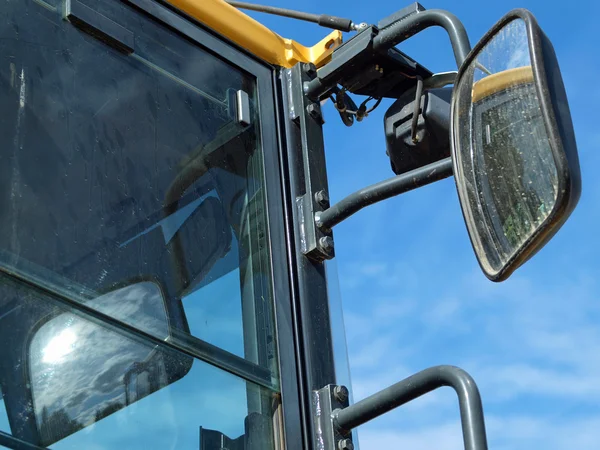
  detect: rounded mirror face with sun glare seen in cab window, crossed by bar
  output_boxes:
[29,281,178,445]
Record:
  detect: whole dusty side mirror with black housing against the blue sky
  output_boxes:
[451,9,581,281]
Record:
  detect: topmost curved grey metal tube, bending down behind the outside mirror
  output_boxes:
[374,9,471,67]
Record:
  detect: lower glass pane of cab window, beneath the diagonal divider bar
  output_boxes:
[0,275,277,450]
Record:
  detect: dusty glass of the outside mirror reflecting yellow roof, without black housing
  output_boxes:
[453,19,559,276]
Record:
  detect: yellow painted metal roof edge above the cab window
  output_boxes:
[168,0,342,67]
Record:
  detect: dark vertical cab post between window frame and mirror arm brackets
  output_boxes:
[278,66,335,450]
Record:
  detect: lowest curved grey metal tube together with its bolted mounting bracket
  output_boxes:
[317,366,488,450]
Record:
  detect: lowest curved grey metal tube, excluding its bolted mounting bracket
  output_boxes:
[333,366,487,450]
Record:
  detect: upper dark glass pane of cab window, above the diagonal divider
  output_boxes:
[0,0,276,377]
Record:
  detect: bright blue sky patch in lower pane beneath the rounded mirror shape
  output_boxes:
[47,361,247,450]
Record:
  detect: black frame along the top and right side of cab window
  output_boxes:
[123,0,310,450]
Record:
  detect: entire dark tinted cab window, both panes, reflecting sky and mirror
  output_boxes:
[0,0,279,450]
